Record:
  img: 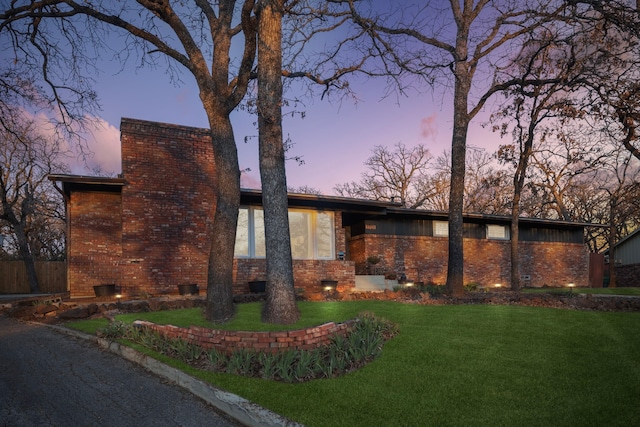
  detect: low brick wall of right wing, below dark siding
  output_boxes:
[349,234,589,287]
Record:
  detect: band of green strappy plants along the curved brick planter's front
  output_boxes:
[99,312,398,383]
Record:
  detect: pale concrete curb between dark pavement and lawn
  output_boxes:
[46,323,303,427]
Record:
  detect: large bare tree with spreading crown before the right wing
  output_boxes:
[348,0,566,295]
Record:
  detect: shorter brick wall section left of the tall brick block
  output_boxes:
[67,192,122,297]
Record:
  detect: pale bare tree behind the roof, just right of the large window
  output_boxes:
[334,142,434,209]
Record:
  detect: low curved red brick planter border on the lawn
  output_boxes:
[133,320,356,353]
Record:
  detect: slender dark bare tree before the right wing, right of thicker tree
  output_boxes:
[492,25,596,291]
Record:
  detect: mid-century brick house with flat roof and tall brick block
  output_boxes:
[50,118,589,297]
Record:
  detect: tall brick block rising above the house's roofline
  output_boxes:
[120,119,215,294]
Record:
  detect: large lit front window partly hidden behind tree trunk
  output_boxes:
[235,207,335,259]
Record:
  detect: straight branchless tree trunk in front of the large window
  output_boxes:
[258,0,300,324]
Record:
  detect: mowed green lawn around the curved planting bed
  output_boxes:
[69,301,640,426]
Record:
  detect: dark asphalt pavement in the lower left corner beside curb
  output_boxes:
[0,315,241,427]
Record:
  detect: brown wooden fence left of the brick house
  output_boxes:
[0,261,67,294]
